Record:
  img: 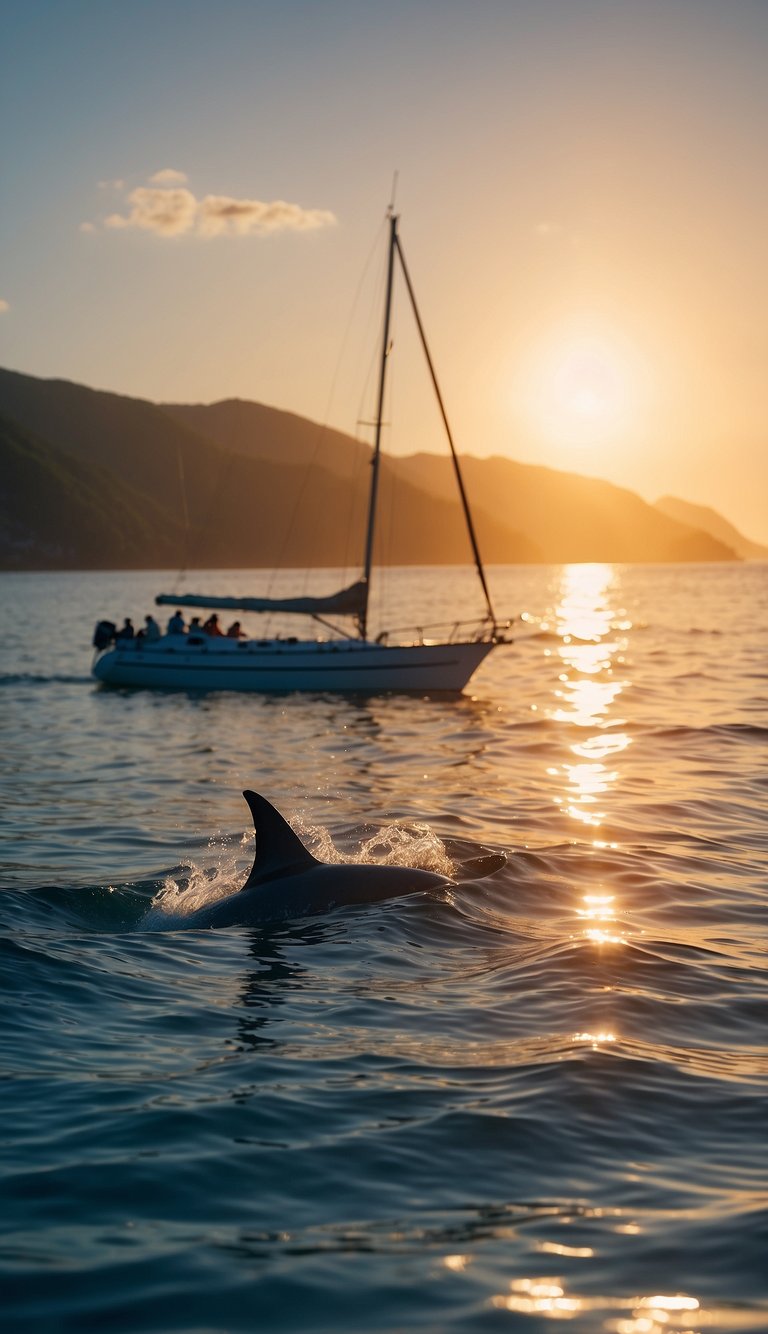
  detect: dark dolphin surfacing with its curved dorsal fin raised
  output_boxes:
[177,791,507,927]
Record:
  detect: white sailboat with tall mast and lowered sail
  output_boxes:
[92,208,509,692]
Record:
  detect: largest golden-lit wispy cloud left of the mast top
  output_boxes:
[80,167,336,237]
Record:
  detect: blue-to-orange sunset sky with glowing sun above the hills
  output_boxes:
[0,0,768,543]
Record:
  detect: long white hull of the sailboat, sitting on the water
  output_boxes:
[93,635,493,691]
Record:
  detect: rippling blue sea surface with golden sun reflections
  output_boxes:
[0,564,768,1334]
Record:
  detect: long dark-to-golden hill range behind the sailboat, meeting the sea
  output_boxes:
[0,371,735,570]
